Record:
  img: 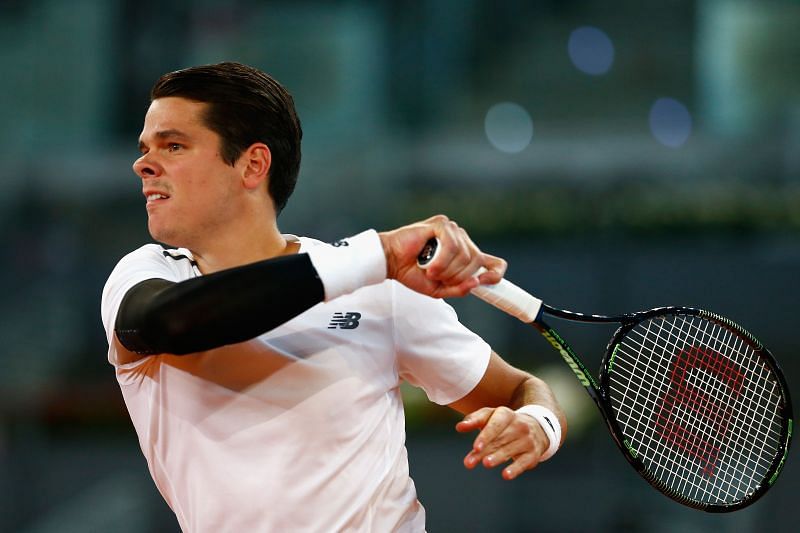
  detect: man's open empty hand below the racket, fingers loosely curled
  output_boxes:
[456,407,550,479]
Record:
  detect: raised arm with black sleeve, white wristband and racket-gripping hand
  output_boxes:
[108,215,505,363]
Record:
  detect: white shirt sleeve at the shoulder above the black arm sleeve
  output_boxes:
[100,244,180,366]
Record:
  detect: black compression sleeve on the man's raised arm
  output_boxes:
[114,254,325,355]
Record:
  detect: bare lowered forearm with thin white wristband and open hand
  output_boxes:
[450,352,567,479]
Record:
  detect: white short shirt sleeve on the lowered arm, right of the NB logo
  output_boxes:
[392,283,491,405]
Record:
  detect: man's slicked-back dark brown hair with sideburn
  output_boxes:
[150,62,303,213]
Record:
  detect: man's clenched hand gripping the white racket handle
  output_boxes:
[379,215,507,298]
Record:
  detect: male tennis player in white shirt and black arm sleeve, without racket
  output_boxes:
[102,63,566,532]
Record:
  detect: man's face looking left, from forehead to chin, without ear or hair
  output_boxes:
[133,97,238,250]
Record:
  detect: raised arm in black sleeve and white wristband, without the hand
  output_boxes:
[109,230,386,363]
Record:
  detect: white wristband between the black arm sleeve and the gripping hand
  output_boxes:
[308,230,386,302]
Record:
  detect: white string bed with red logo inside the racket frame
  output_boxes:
[609,315,782,504]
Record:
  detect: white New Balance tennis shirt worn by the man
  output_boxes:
[101,235,490,533]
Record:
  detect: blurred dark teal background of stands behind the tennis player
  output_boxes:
[0,0,800,533]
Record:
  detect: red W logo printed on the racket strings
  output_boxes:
[655,346,744,477]
